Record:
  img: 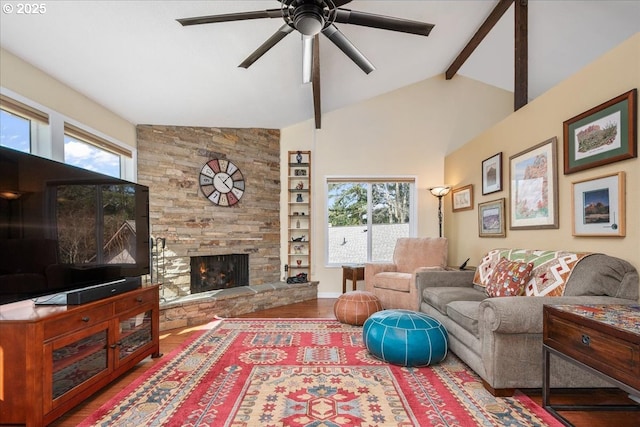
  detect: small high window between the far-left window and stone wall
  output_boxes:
[64,123,131,178]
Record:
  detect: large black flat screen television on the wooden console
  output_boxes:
[0,147,150,304]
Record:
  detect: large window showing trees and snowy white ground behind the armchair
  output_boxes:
[326,178,416,266]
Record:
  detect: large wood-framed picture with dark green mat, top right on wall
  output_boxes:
[564,89,638,175]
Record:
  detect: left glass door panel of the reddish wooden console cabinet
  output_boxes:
[52,325,108,400]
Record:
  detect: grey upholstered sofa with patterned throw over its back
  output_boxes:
[416,249,639,396]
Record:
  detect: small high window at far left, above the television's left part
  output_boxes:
[0,96,49,153]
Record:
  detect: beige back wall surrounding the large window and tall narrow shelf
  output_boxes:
[280,76,513,296]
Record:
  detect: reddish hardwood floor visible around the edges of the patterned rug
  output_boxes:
[51,299,640,427]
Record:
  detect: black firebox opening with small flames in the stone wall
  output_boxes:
[191,254,249,294]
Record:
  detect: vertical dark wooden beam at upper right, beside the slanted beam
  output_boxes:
[513,0,529,111]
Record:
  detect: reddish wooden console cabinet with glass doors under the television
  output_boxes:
[0,285,160,426]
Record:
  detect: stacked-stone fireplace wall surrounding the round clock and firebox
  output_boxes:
[137,125,284,303]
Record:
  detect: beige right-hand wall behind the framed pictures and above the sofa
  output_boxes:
[445,33,640,280]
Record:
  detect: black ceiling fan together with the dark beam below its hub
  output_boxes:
[177,0,434,129]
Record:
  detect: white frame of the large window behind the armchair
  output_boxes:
[323,175,418,268]
